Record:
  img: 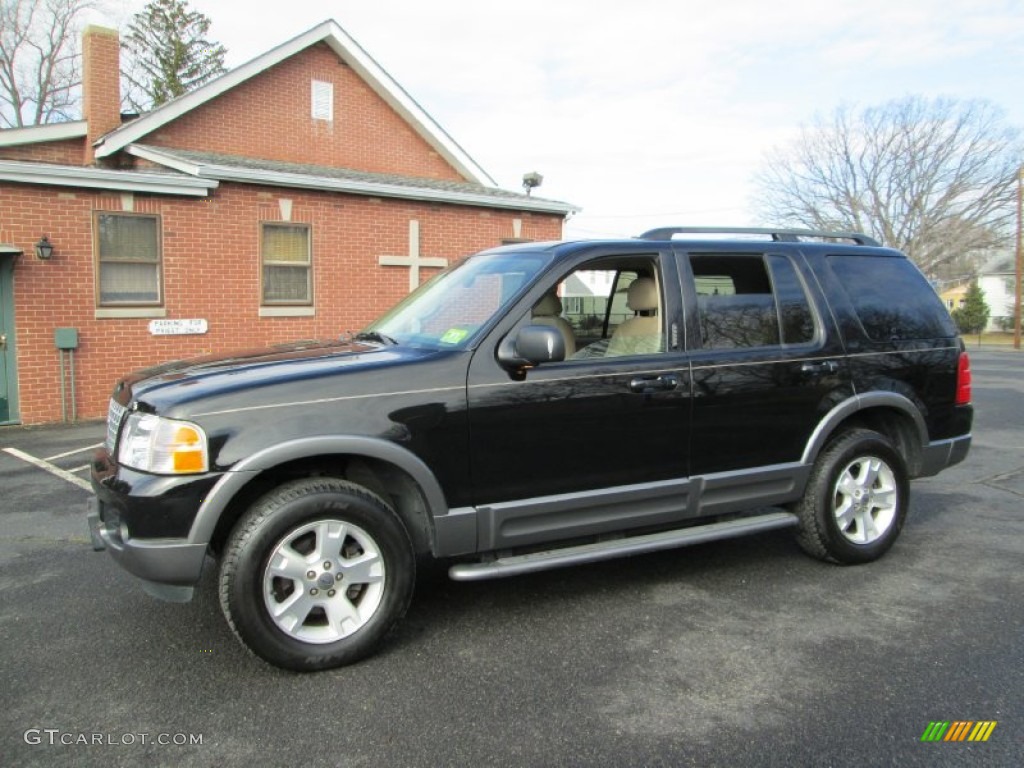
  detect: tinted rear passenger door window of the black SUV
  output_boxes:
[690,254,815,349]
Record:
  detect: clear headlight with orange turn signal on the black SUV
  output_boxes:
[118,412,210,475]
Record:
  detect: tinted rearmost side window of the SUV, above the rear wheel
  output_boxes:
[828,255,956,341]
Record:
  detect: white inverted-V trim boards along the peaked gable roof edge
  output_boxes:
[95,22,495,185]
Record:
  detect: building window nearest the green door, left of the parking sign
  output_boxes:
[96,213,163,306]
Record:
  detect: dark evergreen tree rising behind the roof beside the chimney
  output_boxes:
[121,0,227,112]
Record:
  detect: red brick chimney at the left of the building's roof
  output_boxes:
[82,25,121,163]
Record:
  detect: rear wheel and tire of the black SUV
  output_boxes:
[795,429,910,564]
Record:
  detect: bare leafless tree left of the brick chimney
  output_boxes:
[0,0,93,128]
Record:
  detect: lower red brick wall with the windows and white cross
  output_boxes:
[0,180,562,424]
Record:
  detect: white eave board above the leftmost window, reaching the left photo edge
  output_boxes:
[0,160,218,198]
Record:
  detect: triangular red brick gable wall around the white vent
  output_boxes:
[140,43,462,180]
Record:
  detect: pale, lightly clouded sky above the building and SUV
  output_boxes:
[89,0,1024,238]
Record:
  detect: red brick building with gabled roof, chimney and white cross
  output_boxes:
[0,22,573,424]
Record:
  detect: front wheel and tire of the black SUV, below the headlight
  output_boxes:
[220,477,416,672]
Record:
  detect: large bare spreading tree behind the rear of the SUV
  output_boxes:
[756,96,1021,276]
